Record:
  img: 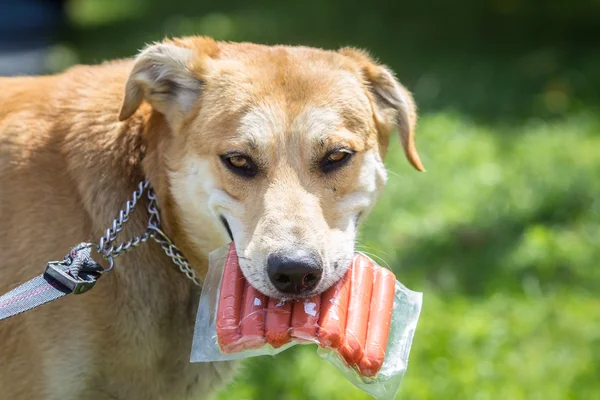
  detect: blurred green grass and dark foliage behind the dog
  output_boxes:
[48,0,600,400]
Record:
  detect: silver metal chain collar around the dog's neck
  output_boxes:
[94,180,202,286]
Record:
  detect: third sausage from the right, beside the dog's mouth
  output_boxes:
[318,269,352,349]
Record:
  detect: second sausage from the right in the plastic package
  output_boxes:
[340,255,374,365]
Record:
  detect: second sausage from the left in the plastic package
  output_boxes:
[241,281,267,350]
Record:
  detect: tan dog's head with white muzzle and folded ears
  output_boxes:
[120,37,423,298]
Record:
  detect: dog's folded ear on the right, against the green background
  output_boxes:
[340,48,425,171]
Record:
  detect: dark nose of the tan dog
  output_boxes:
[267,249,323,295]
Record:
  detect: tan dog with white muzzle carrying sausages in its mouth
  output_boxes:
[0,37,423,400]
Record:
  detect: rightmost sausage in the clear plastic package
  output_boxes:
[358,267,396,376]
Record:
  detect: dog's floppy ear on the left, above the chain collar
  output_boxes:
[119,38,217,126]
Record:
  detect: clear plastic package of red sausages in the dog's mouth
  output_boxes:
[191,243,423,400]
